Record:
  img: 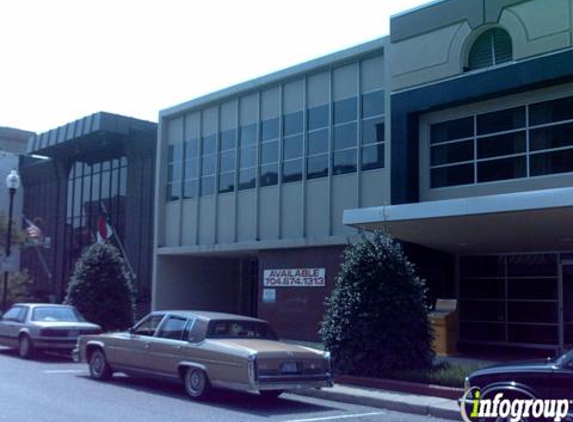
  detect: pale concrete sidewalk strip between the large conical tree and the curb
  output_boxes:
[296,384,461,421]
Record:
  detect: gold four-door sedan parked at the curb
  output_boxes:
[73,311,332,399]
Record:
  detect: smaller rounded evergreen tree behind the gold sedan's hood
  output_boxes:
[65,243,135,331]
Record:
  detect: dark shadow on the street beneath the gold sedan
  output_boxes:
[82,375,340,417]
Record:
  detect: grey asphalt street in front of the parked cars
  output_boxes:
[0,348,452,422]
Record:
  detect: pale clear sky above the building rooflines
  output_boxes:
[0,0,430,133]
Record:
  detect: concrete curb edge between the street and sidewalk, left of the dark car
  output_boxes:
[293,389,460,421]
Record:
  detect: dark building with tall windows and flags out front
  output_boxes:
[20,113,157,310]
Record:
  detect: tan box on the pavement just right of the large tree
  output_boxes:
[430,299,459,355]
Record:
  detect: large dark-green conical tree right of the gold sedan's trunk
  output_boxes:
[320,231,434,377]
